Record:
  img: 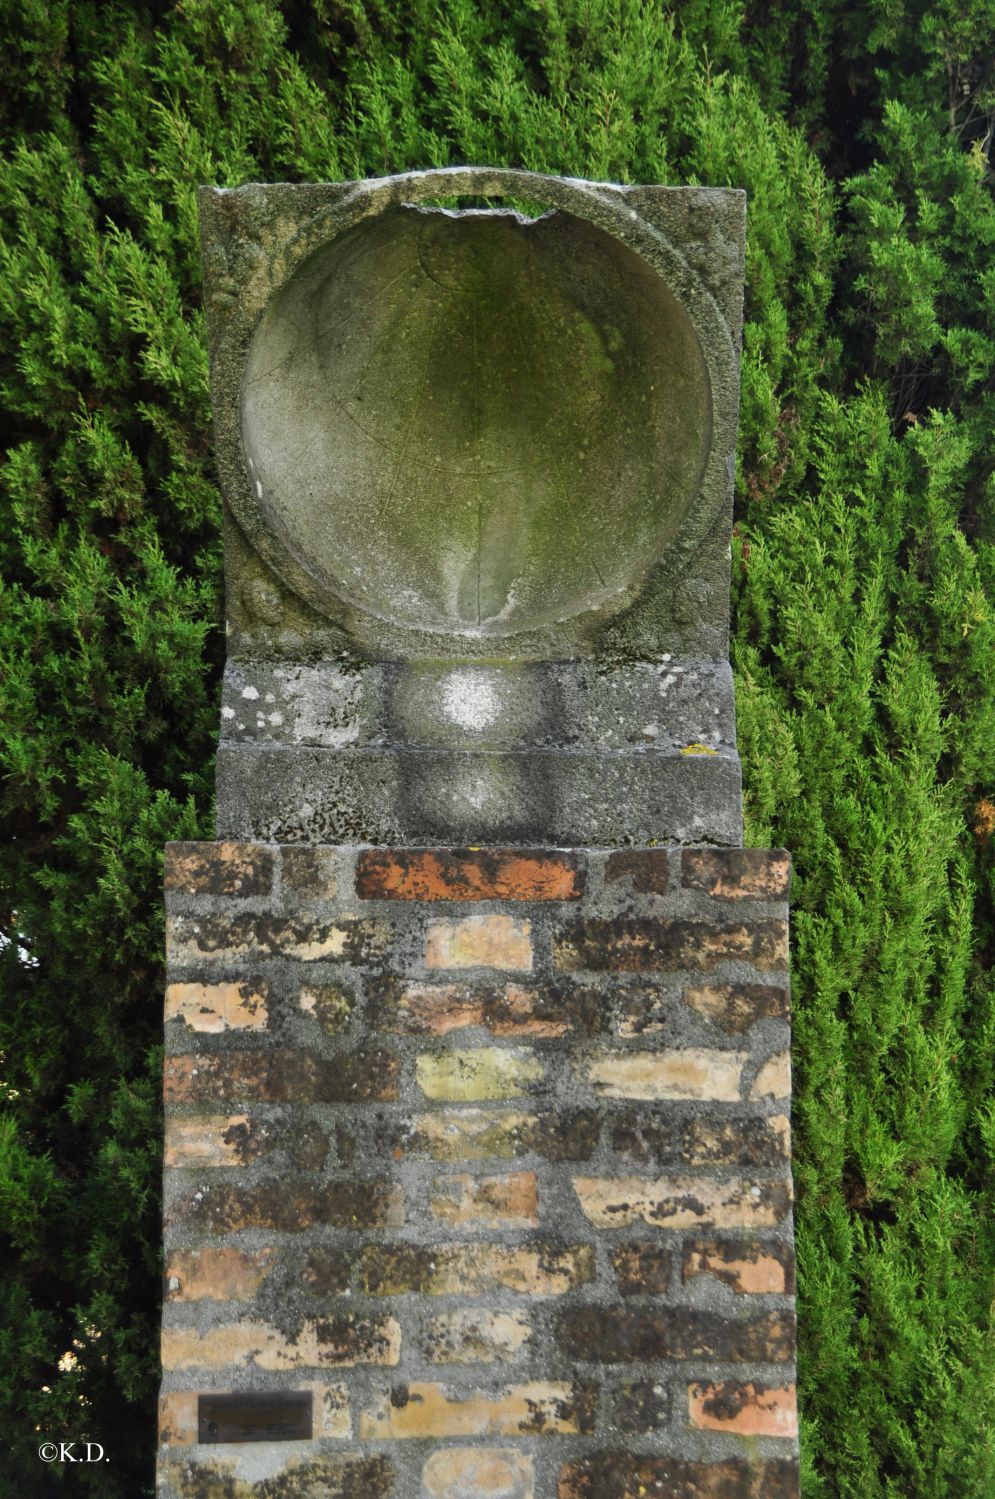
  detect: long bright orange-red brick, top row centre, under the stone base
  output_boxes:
[355,848,586,901]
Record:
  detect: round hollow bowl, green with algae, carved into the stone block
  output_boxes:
[241,205,712,637]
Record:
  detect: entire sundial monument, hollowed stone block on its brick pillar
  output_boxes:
[159,168,797,1499]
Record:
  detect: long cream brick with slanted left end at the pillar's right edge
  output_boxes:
[574,1177,791,1228]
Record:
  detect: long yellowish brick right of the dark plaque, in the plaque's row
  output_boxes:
[360,1379,590,1442]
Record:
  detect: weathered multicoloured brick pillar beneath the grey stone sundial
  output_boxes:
[159,842,797,1499]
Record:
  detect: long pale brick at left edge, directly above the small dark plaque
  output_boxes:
[162,1315,400,1369]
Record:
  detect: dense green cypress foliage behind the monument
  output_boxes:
[0,0,995,1499]
